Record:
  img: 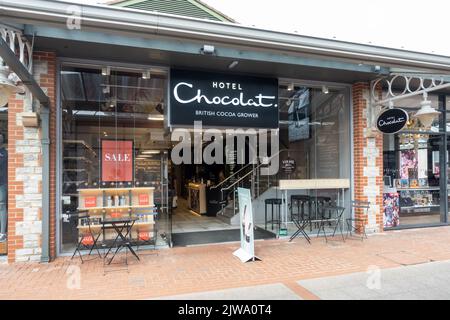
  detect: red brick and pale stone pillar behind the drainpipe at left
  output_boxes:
[8,52,56,262]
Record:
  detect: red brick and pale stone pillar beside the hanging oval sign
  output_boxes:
[353,83,384,233]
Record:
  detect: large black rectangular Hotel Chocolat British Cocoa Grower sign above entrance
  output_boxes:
[169,70,278,129]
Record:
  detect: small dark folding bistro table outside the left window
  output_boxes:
[101,218,140,265]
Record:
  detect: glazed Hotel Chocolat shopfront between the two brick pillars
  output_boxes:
[56,59,351,254]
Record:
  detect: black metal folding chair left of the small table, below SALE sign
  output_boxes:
[71,211,102,263]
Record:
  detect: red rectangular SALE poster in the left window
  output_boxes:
[102,140,133,182]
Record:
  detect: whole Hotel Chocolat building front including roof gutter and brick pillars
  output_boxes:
[0,0,450,262]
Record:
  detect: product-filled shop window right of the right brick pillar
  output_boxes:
[383,92,446,229]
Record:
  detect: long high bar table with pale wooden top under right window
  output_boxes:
[278,179,350,240]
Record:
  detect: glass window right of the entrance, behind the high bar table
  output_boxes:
[260,84,351,234]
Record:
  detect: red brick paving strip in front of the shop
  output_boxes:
[0,227,450,299]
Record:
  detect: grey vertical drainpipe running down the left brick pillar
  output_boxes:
[40,105,50,263]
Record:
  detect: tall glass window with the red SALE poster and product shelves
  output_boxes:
[61,65,170,251]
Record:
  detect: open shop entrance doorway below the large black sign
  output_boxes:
[169,131,275,246]
